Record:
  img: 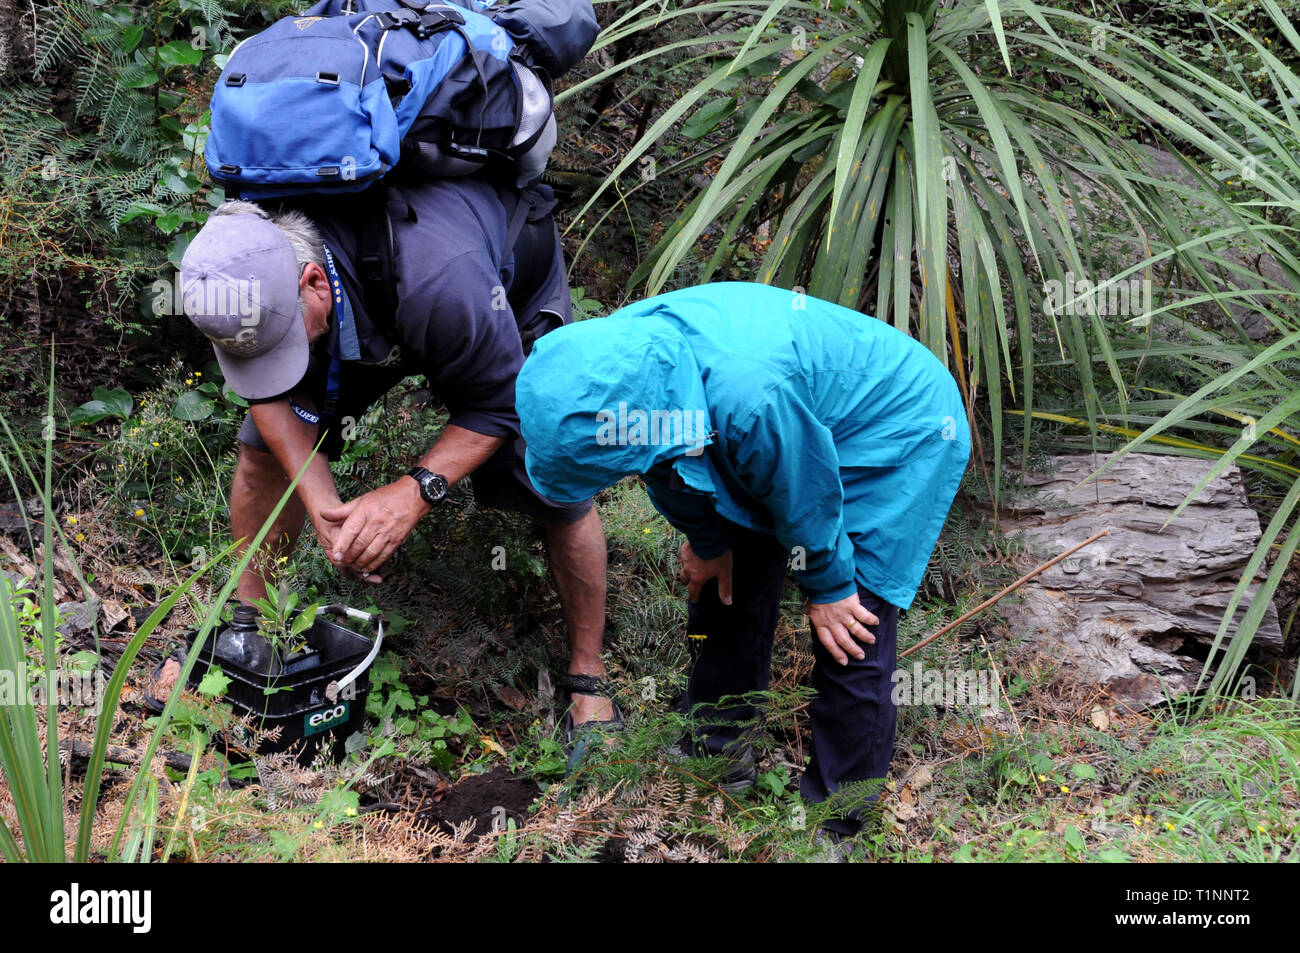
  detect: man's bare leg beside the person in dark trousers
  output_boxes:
[542,506,614,724]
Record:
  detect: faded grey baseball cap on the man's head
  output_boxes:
[181,215,309,400]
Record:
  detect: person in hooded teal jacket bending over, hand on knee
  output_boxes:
[516,282,970,835]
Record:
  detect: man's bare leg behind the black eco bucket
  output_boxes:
[157,443,304,689]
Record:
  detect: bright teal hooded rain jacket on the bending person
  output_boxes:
[515,282,970,608]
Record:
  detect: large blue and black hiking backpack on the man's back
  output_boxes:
[204,0,599,200]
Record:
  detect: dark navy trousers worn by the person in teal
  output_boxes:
[681,524,898,833]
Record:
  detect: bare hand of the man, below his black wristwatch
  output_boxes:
[320,477,432,581]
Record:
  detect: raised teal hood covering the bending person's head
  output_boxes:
[515,316,712,502]
